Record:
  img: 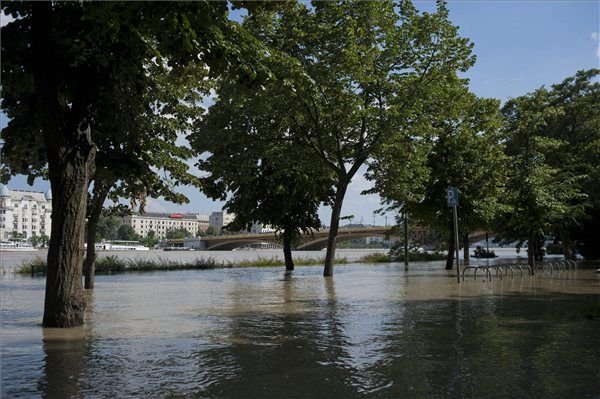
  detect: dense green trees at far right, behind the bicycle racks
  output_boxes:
[496,69,600,265]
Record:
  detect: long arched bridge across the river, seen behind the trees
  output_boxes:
[167,226,485,251]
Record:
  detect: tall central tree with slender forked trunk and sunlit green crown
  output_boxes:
[192,1,474,274]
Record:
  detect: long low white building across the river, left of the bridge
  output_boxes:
[121,213,209,238]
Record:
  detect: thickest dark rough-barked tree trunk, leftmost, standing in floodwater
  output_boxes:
[32,2,96,327]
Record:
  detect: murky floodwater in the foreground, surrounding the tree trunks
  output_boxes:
[0,255,600,398]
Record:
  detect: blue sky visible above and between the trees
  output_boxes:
[0,0,600,225]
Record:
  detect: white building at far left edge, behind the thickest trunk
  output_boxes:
[0,184,52,240]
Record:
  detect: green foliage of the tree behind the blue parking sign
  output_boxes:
[368,79,504,238]
